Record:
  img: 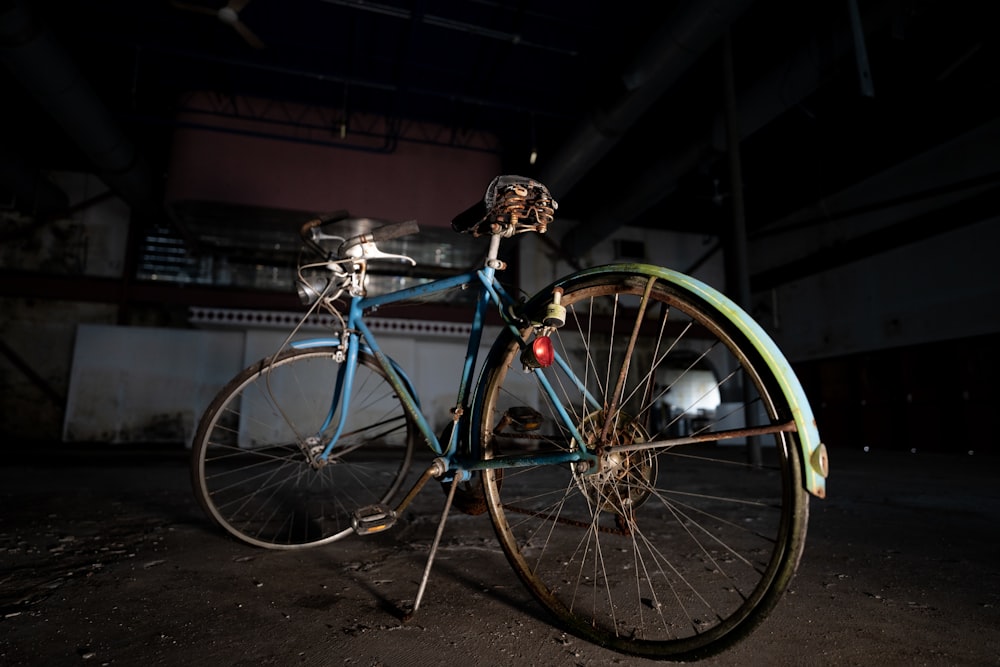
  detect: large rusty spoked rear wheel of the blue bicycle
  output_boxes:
[478,269,809,659]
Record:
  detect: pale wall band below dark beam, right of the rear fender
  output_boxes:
[754,219,1000,361]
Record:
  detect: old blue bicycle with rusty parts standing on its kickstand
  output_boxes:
[192,176,828,659]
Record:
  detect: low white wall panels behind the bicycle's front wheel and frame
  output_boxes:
[63,320,498,445]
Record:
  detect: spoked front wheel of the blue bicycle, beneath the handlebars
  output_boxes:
[191,347,415,549]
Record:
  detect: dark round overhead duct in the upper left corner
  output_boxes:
[0,0,153,213]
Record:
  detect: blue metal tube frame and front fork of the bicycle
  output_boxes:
[290,235,596,481]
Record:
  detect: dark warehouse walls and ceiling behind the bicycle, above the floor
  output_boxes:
[0,0,1000,455]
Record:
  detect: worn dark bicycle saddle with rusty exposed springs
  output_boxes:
[451,175,559,236]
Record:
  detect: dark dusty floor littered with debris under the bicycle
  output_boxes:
[0,448,1000,667]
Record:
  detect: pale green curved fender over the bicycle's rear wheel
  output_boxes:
[528,264,829,498]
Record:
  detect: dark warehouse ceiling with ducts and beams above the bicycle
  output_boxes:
[0,0,1000,266]
